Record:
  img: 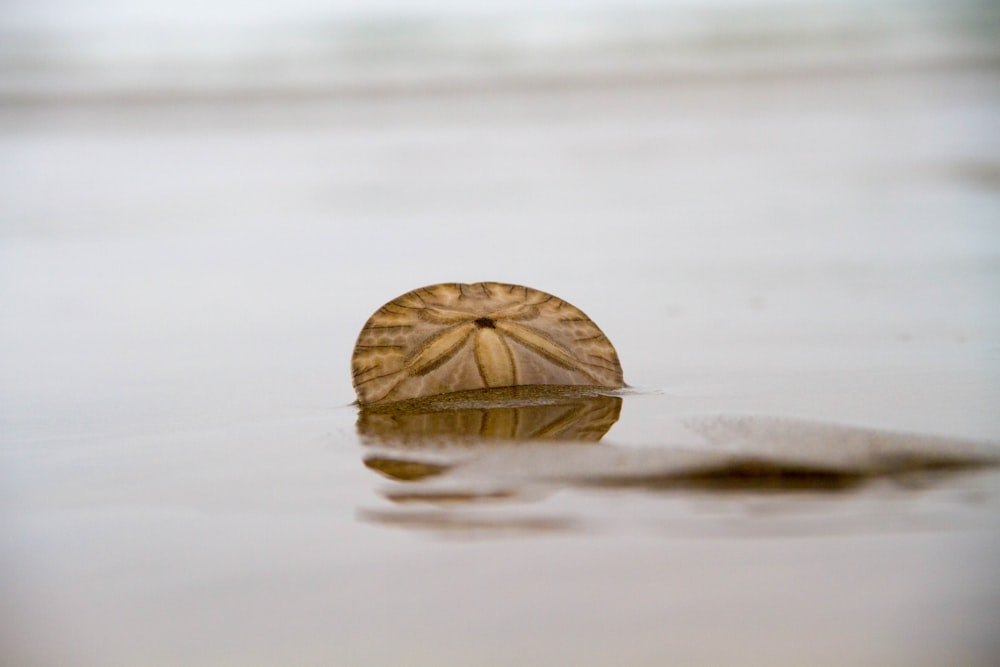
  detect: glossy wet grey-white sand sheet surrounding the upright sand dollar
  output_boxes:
[0,13,1000,665]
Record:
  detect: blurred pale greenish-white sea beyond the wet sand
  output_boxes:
[0,0,1000,103]
